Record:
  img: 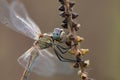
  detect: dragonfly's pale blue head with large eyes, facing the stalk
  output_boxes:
[52,28,64,40]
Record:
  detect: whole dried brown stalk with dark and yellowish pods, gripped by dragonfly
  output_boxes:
[59,0,91,80]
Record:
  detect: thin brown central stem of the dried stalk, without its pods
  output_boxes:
[63,0,90,80]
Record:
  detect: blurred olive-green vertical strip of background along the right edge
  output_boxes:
[109,0,120,80]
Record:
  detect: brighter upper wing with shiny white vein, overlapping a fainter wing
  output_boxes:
[10,0,41,40]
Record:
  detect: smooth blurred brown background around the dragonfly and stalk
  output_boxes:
[0,0,120,80]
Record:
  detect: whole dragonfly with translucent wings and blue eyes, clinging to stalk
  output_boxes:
[0,0,76,80]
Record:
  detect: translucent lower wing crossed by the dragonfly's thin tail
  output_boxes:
[18,47,55,76]
